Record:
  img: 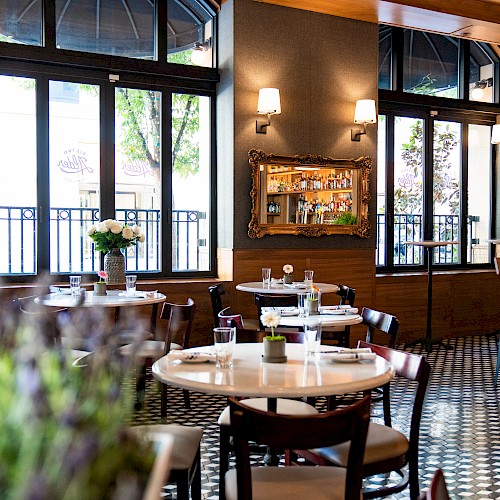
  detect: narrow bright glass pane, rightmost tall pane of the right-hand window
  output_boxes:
[467,125,493,264]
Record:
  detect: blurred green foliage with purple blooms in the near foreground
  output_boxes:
[0,298,154,500]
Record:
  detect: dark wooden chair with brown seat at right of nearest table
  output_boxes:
[290,341,431,498]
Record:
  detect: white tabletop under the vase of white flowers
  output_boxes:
[35,290,167,307]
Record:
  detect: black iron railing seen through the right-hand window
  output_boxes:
[376,214,479,266]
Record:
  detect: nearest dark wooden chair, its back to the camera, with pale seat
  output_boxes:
[225,397,370,500]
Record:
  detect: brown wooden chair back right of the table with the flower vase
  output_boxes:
[160,298,196,354]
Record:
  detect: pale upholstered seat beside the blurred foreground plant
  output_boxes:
[132,424,203,470]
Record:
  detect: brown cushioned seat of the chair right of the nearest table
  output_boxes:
[313,422,409,467]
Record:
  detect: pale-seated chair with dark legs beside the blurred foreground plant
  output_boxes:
[131,424,203,500]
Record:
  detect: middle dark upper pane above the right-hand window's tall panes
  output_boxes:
[403,29,458,99]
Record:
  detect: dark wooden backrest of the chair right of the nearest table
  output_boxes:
[358,340,431,472]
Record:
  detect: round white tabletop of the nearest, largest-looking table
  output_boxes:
[153,343,394,398]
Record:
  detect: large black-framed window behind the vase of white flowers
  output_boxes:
[0,0,217,279]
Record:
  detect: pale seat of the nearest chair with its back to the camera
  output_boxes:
[225,467,352,500]
